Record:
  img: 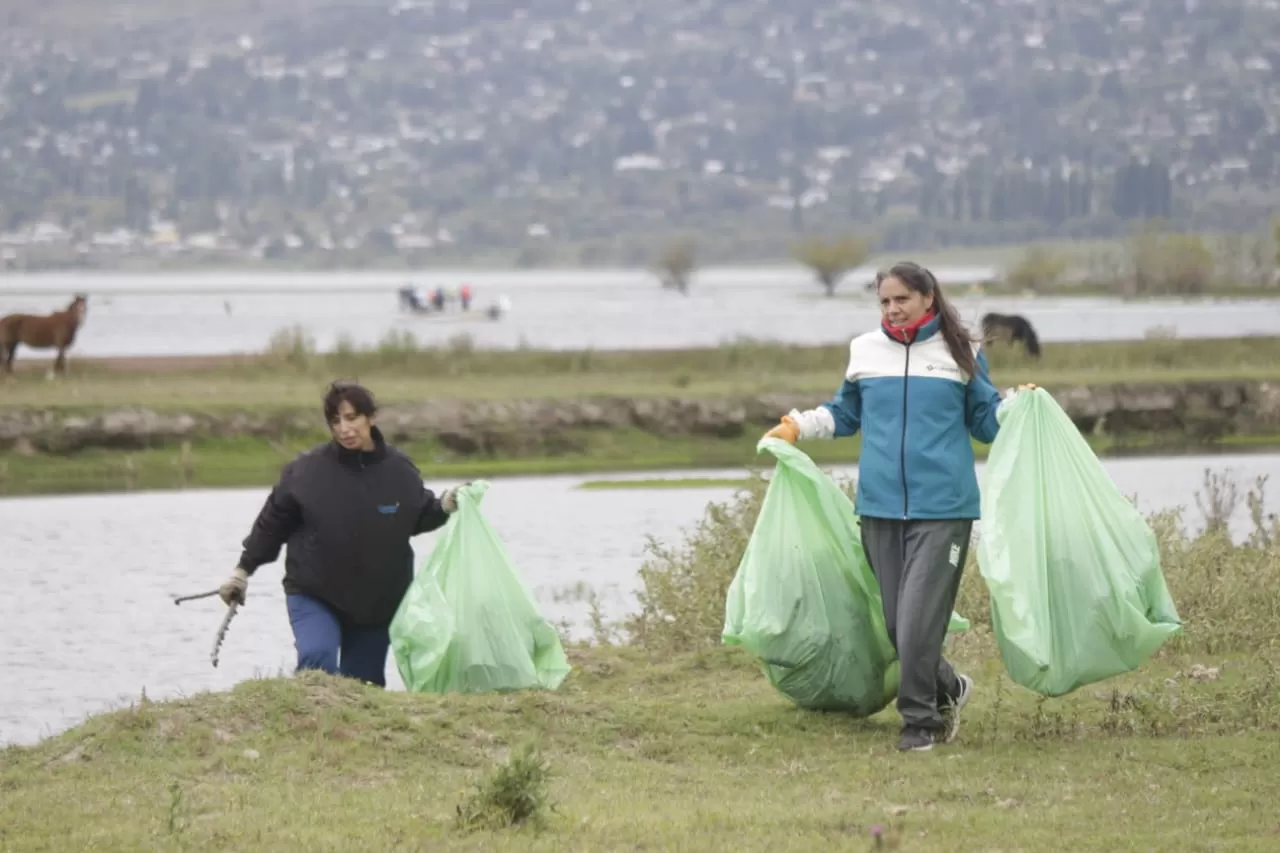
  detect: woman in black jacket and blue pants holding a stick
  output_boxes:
[219,382,471,686]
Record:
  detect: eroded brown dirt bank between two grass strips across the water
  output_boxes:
[0,382,1280,455]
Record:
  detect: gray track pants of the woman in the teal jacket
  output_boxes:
[860,516,973,729]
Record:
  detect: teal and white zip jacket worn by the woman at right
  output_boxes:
[791,318,1001,519]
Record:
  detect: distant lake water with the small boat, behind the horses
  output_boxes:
[0,266,1280,359]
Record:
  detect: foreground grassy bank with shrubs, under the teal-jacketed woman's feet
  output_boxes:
[0,473,1280,853]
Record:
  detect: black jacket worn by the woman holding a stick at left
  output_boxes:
[239,427,449,625]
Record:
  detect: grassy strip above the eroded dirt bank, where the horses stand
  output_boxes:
[0,333,1280,411]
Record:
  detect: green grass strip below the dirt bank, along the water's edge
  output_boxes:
[0,429,1280,497]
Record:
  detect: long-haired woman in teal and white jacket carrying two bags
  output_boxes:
[768,257,1034,751]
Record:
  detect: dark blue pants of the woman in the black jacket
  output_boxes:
[284,596,390,686]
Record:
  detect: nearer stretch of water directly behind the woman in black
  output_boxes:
[0,453,1280,744]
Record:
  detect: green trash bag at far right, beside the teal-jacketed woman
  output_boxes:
[978,388,1181,695]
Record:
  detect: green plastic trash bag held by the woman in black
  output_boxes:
[390,480,570,693]
